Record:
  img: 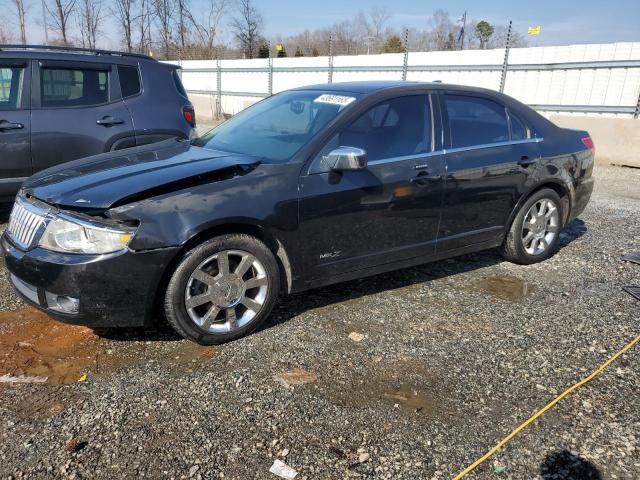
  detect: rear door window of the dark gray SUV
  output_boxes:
[41,68,109,107]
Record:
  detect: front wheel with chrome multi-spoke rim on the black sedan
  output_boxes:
[164,234,280,345]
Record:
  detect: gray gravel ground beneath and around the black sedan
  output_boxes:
[0,167,640,479]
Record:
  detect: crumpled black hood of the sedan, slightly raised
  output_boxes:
[22,140,260,209]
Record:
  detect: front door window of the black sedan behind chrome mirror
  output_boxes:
[310,95,431,173]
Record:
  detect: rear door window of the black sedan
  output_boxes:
[445,95,509,148]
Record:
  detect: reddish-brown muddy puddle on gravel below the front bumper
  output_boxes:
[0,308,216,384]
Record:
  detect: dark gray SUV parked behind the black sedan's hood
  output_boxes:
[0,45,195,201]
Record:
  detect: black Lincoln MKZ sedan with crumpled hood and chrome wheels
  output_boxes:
[2,82,594,344]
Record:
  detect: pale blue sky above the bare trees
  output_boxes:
[17,0,640,48]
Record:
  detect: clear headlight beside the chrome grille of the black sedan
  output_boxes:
[38,217,134,254]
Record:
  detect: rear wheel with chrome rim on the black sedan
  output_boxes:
[500,188,565,265]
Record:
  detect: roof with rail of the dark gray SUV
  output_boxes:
[0,45,157,65]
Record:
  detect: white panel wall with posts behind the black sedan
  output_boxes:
[166,42,640,117]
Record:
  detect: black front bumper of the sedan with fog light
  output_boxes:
[0,233,179,327]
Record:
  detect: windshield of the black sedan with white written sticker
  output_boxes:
[194,90,360,163]
